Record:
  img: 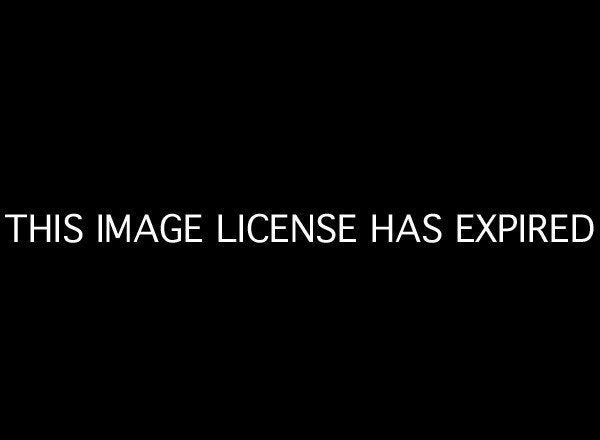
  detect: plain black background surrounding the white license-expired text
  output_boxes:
[1,5,598,433]
